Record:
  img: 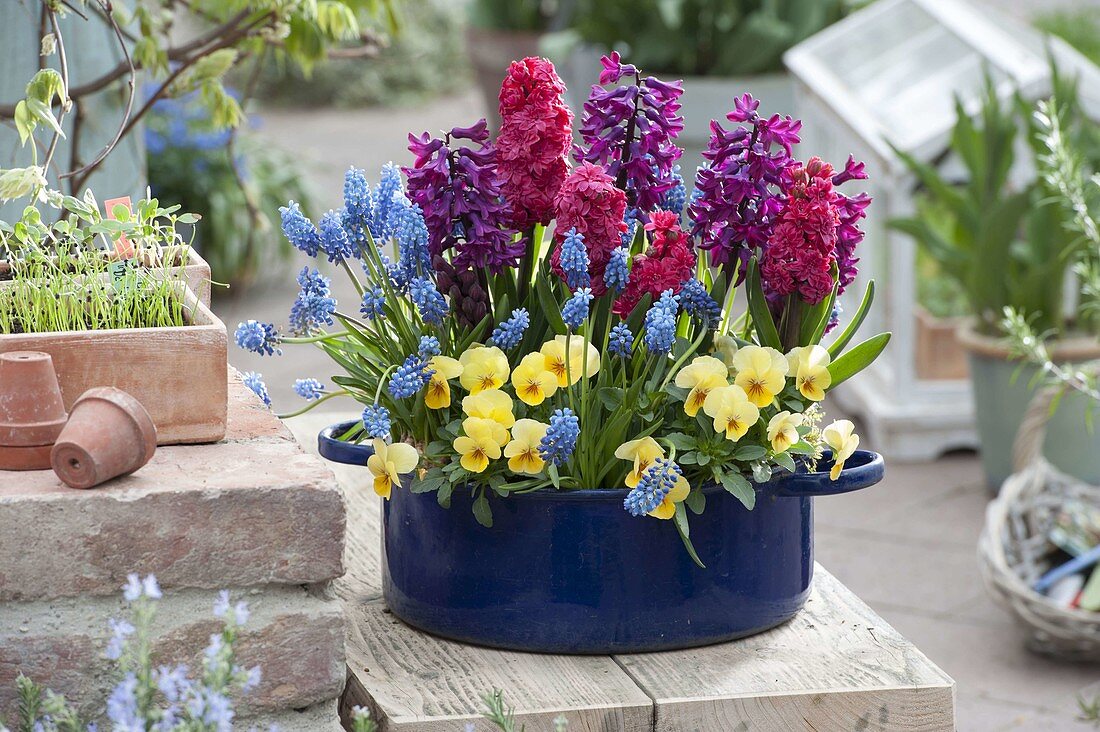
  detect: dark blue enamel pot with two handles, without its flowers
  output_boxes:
[319,425,884,654]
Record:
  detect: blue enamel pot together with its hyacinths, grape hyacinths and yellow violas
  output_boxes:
[235,54,890,653]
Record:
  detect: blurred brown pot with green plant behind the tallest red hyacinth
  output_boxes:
[466,0,568,132]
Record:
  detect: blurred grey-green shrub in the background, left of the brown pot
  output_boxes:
[257,0,470,108]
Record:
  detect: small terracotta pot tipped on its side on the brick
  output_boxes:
[51,386,156,488]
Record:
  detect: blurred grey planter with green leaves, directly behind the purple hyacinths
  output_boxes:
[554,0,851,165]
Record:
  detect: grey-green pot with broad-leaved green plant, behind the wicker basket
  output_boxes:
[891,73,1100,490]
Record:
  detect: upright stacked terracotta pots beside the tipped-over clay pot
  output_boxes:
[0,351,68,470]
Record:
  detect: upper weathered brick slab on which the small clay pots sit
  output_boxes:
[0,376,345,602]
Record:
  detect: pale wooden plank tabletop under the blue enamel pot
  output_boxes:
[287,414,955,732]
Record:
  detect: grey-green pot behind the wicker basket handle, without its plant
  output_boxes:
[959,321,1100,493]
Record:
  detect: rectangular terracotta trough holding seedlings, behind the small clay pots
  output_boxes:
[0,289,228,445]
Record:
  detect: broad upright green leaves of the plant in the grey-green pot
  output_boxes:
[890,69,1100,332]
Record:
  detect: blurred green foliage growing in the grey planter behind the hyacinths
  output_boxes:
[573,0,849,76]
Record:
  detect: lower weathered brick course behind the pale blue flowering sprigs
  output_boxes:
[0,586,347,718]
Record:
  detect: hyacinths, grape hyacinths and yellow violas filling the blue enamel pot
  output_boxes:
[235,55,890,559]
